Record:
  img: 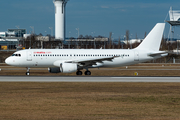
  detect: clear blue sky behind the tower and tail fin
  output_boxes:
[0,0,180,38]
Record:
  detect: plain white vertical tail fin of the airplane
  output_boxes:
[135,23,165,51]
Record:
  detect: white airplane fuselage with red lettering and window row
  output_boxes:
[6,49,158,67]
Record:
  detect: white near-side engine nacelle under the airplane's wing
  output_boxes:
[60,63,77,73]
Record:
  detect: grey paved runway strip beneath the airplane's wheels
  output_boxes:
[0,76,180,83]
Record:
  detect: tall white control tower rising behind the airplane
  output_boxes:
[53,0,69,40]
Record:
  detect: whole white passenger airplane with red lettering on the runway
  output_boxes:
[5,23,168,75]
